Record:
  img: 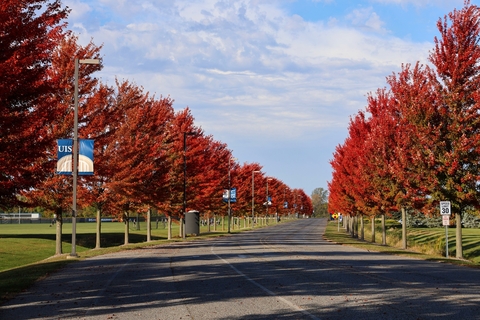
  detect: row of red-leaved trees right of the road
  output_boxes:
[329,1,480,258]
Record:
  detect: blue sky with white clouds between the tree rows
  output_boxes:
[64,0,472,194]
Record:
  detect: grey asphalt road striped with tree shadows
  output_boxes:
[0,219,480,320]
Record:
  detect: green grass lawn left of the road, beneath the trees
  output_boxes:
[0,218,276,304]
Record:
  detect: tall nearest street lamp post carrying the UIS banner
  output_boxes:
[70,58,100,257]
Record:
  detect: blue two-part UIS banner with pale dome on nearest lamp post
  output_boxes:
[56,139,93,176]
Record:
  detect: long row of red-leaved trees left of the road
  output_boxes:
[0,0,312,253]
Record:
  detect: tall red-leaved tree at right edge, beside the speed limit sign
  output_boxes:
[430,1,480,258]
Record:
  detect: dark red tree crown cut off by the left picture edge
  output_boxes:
[0,0,67,207]
